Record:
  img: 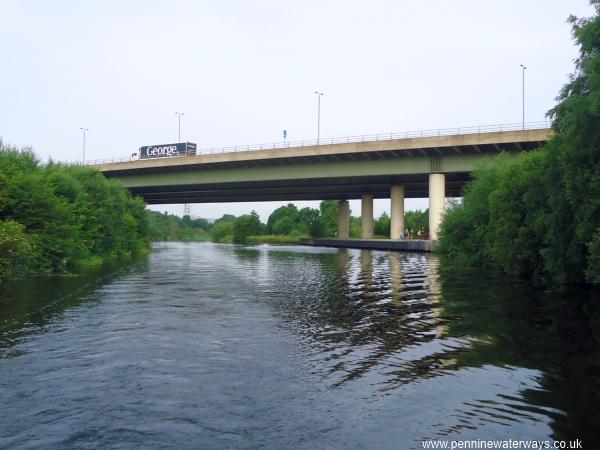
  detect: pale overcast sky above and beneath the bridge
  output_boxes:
[0,0,592,221]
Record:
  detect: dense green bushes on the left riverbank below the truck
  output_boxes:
[0,145,148,280]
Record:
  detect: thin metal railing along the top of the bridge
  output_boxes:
[82,120,551,165]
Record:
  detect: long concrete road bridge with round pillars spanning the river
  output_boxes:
[91,122,552,240]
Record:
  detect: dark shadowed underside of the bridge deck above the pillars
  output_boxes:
[129,172,470,205]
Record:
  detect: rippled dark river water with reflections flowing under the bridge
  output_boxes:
[0,243,600,449]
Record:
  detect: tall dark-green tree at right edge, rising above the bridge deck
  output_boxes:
[544,0,600,282]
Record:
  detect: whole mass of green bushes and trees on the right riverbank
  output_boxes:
[439,6,600,284]
